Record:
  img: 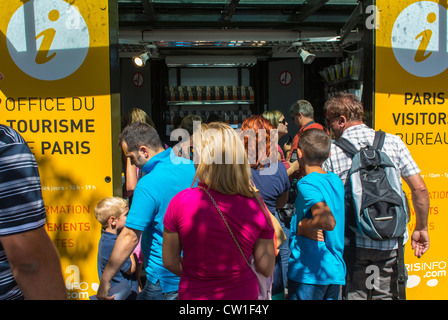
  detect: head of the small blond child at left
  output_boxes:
[95,197,129,230]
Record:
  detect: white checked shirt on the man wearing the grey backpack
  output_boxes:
[322,124,420,250]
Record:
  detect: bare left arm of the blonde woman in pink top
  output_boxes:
[162,228,182,277]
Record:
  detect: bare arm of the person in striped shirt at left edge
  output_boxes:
[0,227,67,300]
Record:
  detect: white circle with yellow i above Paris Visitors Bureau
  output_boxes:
[392,1,448,77]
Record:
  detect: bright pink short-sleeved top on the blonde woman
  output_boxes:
[163,185,274,300]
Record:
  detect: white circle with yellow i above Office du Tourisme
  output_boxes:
[6,0,90,81]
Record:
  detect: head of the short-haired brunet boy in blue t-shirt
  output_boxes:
[298,129,331,165]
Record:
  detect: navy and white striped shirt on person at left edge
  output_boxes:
[0,124,46,300]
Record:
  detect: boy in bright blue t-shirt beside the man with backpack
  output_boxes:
[288,129,346,300]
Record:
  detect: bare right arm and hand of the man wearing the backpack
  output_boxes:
[403,174,429,258]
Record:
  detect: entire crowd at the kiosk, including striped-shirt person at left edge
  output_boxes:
[0,65,429,300]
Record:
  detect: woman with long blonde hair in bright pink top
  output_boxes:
[163,122,275,300]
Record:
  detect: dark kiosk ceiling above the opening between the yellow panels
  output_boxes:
[118,0,365,56]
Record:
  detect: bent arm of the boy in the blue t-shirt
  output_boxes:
[297,202,336,241]
